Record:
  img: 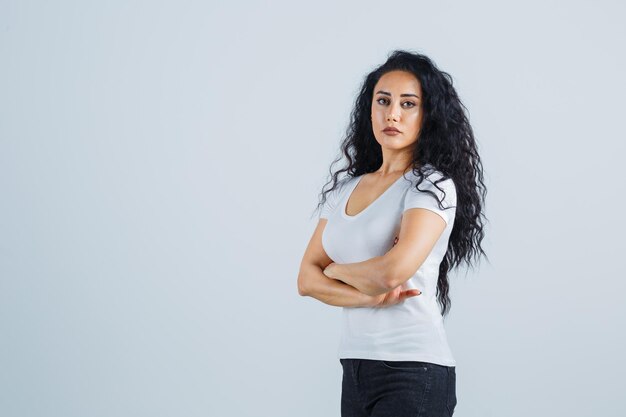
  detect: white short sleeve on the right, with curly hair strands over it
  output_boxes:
[402,173,456,225]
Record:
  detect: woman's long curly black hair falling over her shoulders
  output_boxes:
[318,50,487,317]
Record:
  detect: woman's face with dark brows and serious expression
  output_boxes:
[372,71,422,150]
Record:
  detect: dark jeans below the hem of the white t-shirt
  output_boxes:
[339,359,456,417]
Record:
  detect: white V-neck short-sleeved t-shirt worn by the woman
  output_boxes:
[319,166,456,366]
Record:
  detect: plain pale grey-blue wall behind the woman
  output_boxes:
[0,1,626,417]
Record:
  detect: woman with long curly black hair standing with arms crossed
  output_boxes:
[298,51,486,417]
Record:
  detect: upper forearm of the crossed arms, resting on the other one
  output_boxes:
[323,256,390,296]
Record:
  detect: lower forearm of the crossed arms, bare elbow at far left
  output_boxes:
[301,265,377,307]
